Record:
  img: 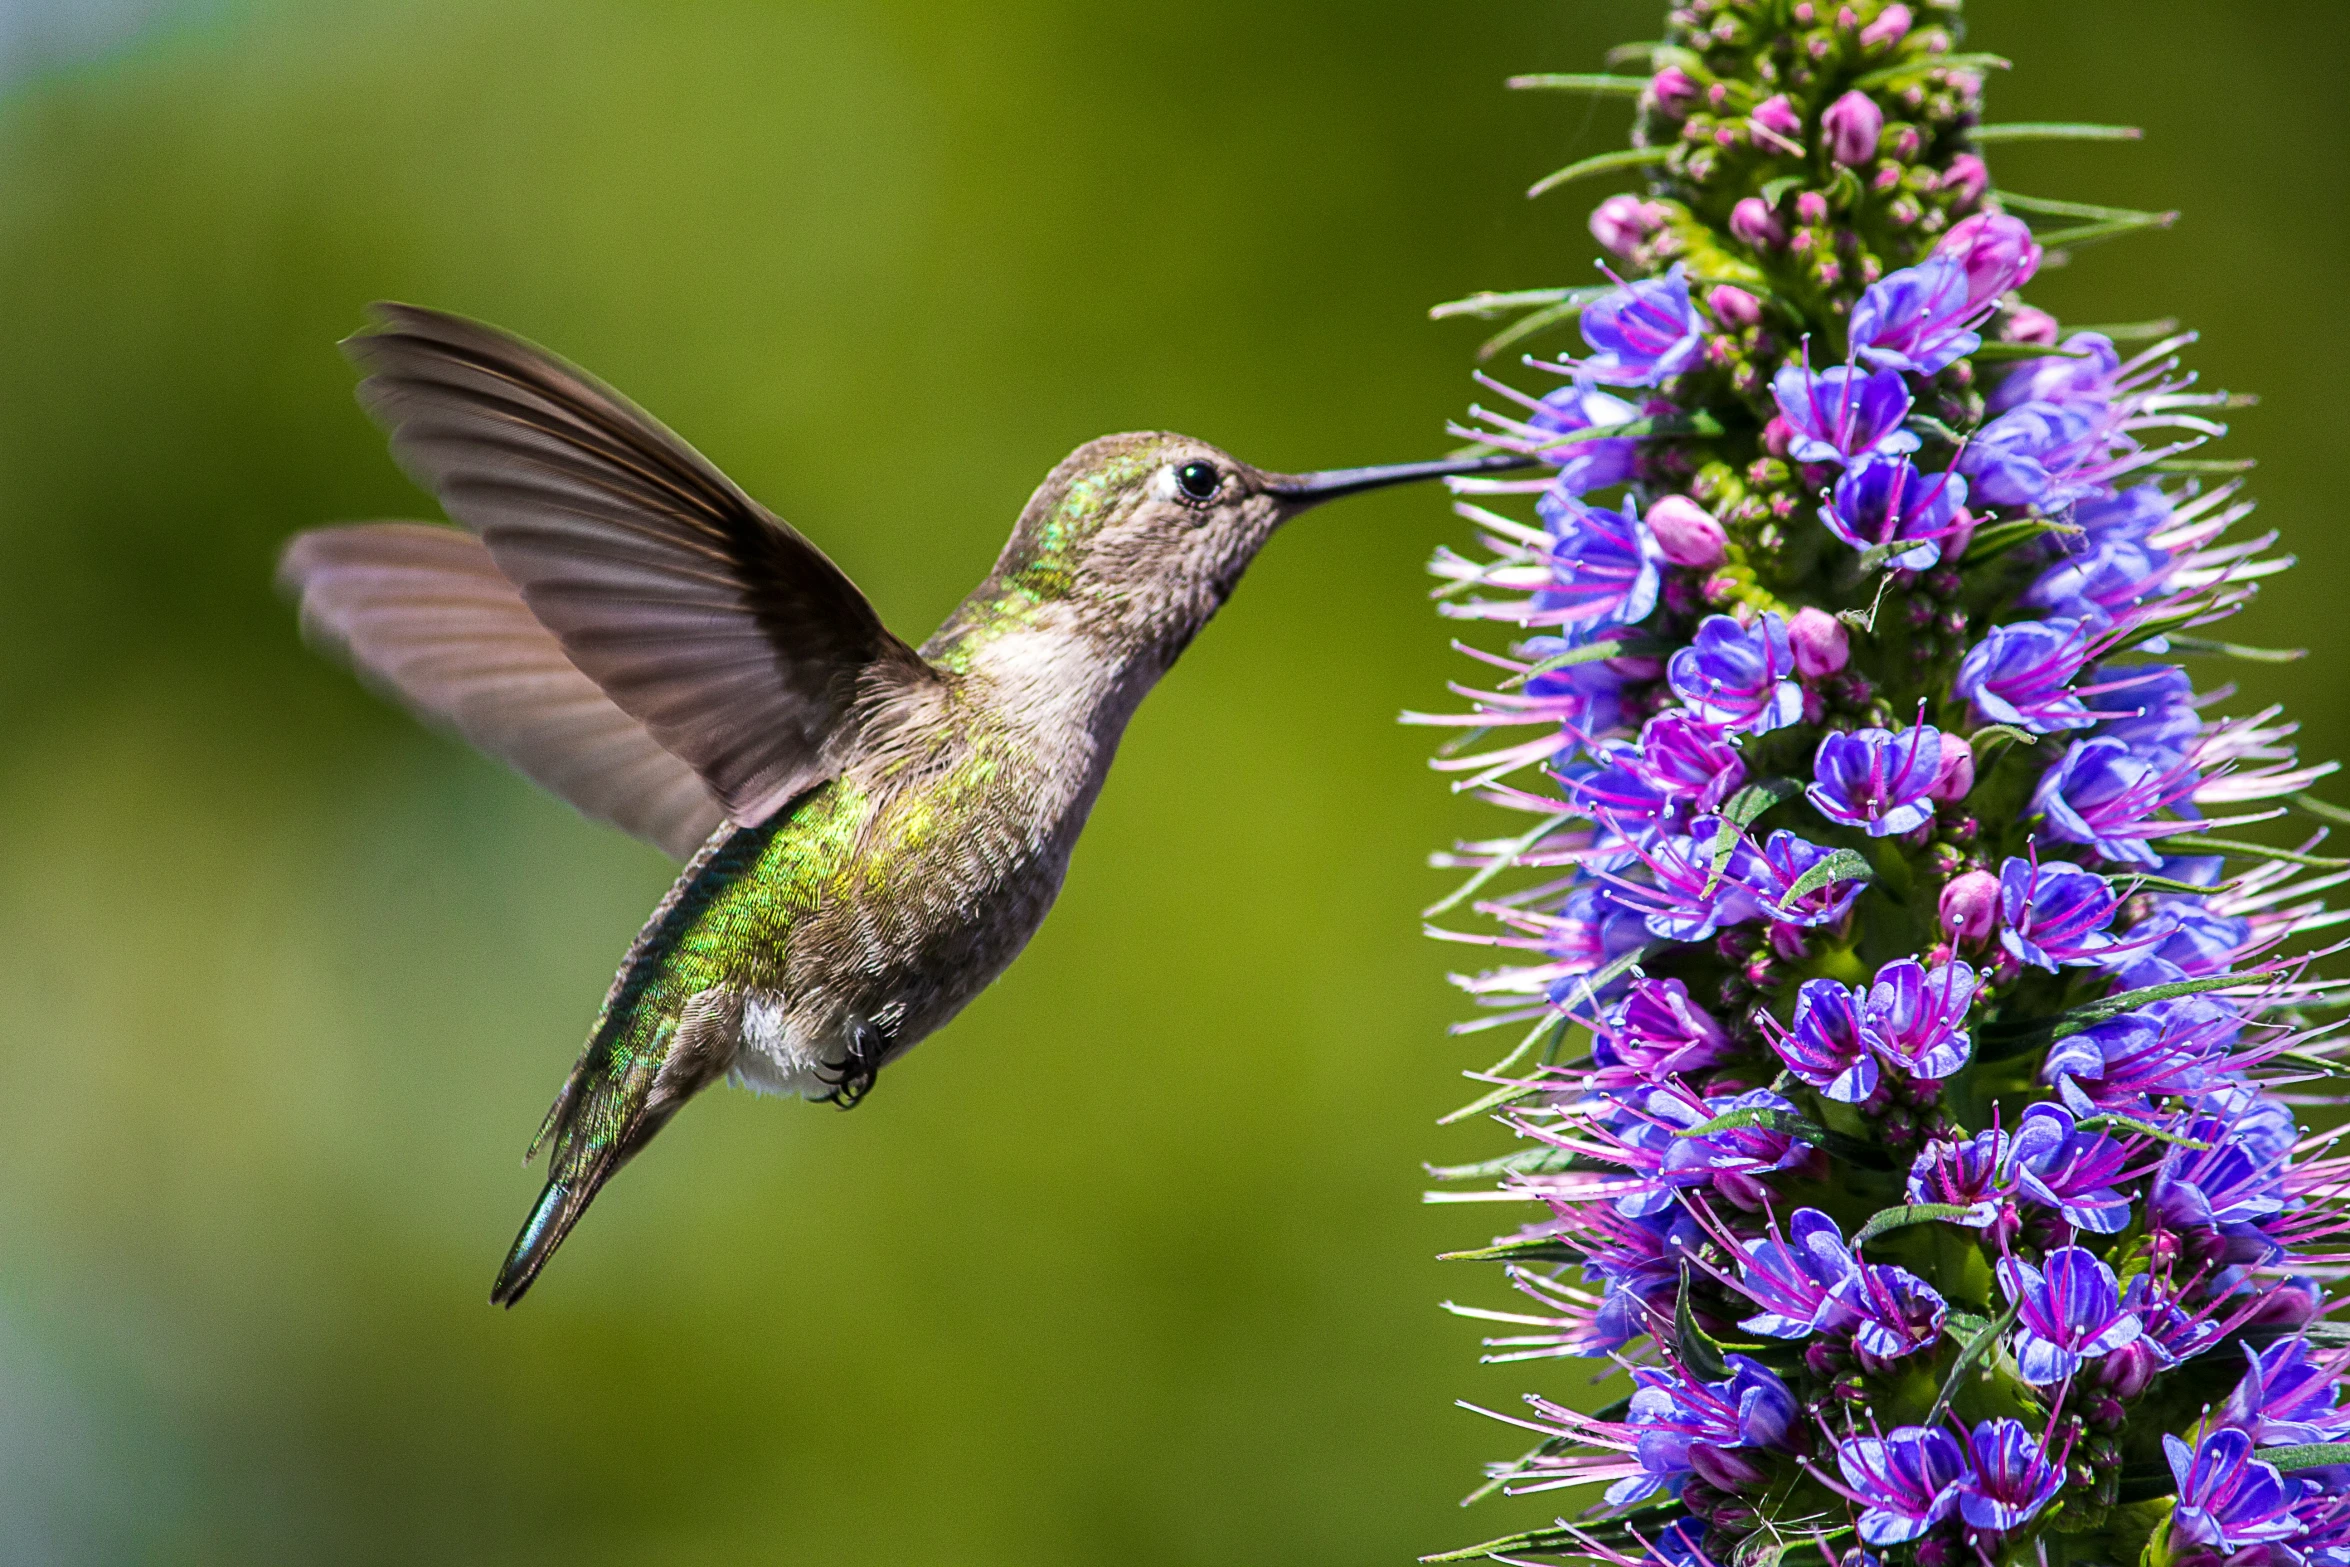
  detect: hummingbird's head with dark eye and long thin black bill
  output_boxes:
[996,432,1525,646]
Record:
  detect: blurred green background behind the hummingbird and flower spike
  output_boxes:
[0,0,2350,1567]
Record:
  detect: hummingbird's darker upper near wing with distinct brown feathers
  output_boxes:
[343,305,938,827]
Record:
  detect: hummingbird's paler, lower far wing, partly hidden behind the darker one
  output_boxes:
[277,522,726,860]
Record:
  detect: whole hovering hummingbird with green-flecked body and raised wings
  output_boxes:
[280,305,1525,1306]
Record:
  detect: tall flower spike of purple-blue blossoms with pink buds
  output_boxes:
[1431,0,2350,1567]
